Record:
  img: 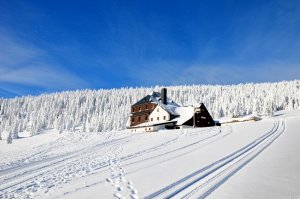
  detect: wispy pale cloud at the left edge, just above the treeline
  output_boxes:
[0,32,88,96]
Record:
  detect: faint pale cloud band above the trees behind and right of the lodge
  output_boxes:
[130,59,300,86]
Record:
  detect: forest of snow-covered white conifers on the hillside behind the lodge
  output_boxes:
[0,81,300,139]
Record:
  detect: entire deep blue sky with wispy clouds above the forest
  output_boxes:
[0,0,300,98]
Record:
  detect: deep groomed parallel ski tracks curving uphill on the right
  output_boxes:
[146,121,285,199]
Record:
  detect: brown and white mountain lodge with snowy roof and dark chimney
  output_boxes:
[127,88,219,132]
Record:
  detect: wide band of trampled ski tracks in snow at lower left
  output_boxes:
[0,133,141,198]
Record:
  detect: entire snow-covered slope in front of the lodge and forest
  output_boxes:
[0,111,300,199]
